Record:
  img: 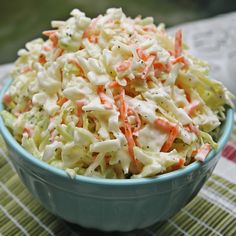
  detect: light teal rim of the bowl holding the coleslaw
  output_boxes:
[0,78,234,186]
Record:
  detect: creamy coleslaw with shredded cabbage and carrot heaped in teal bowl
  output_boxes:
[1,8,233,178]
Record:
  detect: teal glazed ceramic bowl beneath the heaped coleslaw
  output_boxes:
[0,79,233,231]
